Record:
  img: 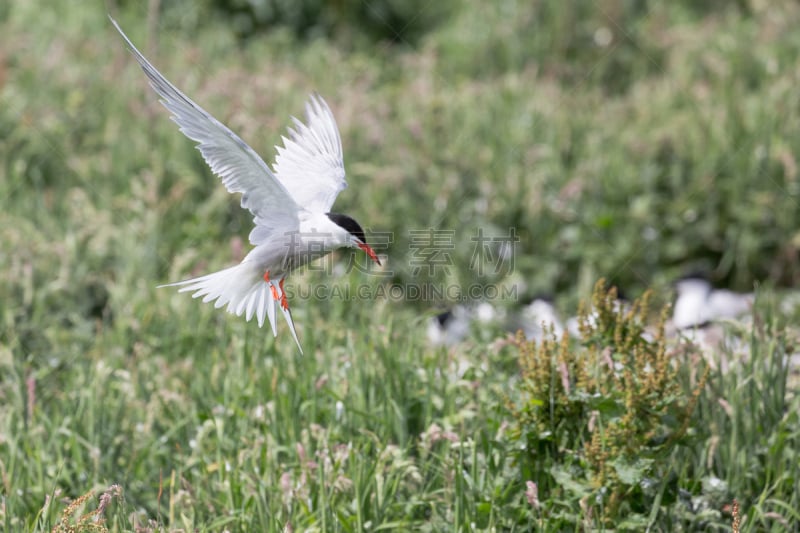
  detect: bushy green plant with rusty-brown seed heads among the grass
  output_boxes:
[509,280,708,522]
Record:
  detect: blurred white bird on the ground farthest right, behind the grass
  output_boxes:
[672,276,754,329]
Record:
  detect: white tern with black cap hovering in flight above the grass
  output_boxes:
[111,19,380,353]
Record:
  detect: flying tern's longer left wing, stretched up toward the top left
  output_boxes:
[109,17,302,235]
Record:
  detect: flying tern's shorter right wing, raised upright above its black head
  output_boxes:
[273,93,347,213]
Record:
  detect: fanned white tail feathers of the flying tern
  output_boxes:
[159,261,303,353]
